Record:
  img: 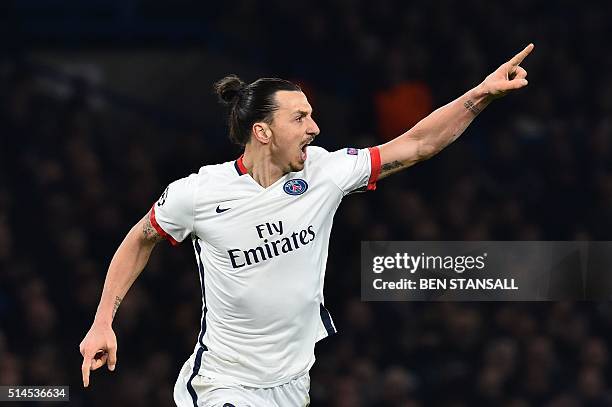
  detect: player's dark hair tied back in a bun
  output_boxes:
[214,75,302,146]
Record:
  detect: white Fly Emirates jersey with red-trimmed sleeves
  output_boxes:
[150,146,380,387]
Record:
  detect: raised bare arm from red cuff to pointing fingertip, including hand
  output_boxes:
[378,44,533,179]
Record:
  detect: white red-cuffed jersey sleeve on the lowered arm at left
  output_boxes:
[149,174,196,246]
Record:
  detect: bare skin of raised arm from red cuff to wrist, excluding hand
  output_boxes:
[378,85,491,179]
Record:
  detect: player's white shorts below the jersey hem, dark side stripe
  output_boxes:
[174,360,310,407]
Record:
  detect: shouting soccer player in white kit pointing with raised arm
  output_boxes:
[80,44,533,407]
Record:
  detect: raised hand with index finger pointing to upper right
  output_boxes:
[481,44,534,98]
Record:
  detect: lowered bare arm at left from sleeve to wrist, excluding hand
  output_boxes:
[95,221,155,324]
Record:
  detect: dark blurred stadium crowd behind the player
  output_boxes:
[0,0,612,407]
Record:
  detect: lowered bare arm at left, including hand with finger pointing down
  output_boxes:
[79,214,163,387]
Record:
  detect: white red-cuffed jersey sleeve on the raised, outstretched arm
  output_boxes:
[325,147,380,195]
